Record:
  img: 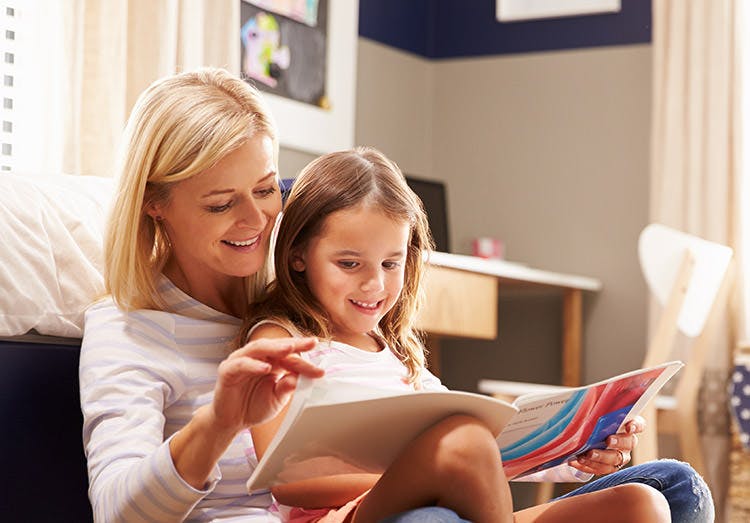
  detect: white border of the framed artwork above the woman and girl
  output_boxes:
[256,0,359,154]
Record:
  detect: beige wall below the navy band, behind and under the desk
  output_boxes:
[356,38,651,390]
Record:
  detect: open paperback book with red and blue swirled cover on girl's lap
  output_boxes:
[247,361,683,491]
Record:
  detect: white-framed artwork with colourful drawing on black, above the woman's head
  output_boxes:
[240,0,358,154]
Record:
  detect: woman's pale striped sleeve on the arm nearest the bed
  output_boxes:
[79,304,206,522]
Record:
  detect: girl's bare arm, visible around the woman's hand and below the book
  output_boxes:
[250,324,380,508]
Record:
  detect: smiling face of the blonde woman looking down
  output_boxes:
[154,134,281,297]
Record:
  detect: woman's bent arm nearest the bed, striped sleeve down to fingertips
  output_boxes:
[79,302,322,522]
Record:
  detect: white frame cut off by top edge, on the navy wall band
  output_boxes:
[495,0,622,22]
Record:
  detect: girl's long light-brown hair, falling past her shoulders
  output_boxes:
[247,147,432,382]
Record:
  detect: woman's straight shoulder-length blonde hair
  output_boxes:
[104,68,278,310]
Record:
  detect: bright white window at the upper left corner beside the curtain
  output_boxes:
[0,0,70,176]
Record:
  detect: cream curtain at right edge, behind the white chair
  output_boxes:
[650,0,745,521]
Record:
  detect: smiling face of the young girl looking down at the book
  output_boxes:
[292,206,410,348]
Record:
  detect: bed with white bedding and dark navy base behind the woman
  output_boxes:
[0,173,114,522]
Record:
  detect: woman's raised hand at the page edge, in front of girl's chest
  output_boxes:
[211,338,323,433]
